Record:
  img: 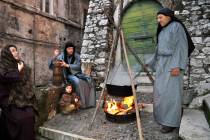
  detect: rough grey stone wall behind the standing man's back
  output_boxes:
[179,0,210,87]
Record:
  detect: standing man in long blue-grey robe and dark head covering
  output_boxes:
[147,8,192,133]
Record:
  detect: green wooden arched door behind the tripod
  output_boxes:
[122,0,161,69]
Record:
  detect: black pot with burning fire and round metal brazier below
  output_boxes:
[104,84,136,123]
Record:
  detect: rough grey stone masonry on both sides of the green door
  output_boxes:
[81,0,210,87]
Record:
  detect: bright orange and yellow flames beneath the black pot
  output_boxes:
[105,96,134,115]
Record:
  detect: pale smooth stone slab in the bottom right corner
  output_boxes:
[179,109,210,140]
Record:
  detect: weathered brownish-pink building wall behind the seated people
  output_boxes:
[0,0,89,86]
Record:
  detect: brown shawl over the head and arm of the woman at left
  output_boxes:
[0,45,36,109]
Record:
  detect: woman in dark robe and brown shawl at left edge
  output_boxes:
[0,45,36,140]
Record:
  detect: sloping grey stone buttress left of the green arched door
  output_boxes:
[81,0,112,87]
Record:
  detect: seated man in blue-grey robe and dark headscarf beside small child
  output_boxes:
[48,42,96,108]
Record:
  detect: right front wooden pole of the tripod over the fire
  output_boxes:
[120,29,144,140]
